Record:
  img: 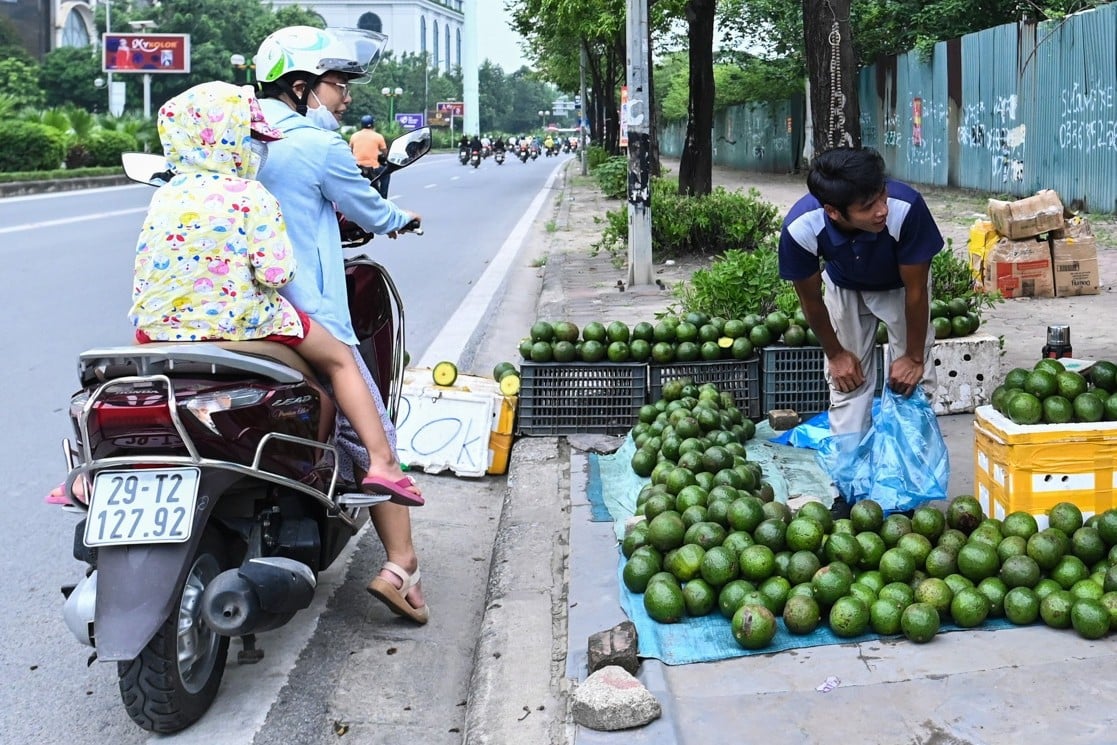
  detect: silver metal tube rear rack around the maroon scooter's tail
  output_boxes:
[63,370,357,528]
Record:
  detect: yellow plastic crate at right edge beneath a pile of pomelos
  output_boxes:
[974,405,1117,527]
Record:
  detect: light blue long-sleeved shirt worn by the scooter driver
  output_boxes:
[259,98,411,345]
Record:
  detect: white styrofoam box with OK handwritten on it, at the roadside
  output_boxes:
[395,367,503,476]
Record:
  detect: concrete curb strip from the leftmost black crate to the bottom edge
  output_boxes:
[461,438,571,745]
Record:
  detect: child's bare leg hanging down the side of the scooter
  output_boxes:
[295,321,420,498]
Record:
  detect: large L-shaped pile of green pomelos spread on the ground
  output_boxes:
[621,380,1117,649]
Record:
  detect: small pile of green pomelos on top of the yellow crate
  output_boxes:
[991,359,1117,424]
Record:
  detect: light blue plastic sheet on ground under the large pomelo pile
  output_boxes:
[586,423,1012,665]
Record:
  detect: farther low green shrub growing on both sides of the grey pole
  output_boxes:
[593,179,780,259]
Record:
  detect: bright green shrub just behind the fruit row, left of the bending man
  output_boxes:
[674,240,799,318]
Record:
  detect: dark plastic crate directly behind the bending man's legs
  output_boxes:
[761,344,885,419]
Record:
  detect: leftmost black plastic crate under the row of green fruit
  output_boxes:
[517,362,648,434]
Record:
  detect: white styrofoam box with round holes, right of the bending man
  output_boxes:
[927,334,1001,416]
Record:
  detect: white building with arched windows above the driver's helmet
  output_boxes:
[270,0,466,73]
